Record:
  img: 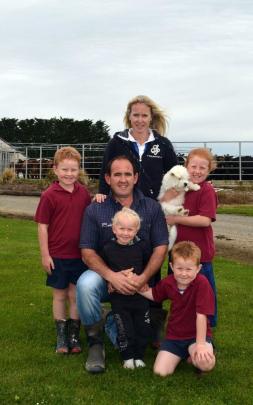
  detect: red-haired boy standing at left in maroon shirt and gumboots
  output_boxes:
[35,147,91,353]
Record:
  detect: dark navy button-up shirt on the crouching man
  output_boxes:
[80,188,168,255]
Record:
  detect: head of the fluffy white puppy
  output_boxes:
[162,165,189,191]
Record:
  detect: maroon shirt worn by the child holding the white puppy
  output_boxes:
[176,181,218,263]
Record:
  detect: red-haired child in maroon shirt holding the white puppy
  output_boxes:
[166,148,218,327]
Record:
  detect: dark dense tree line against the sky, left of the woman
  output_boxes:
[0,117,110,144]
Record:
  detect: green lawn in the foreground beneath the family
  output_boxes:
[0,218,253,405]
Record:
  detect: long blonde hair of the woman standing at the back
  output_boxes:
[124,96,168,135]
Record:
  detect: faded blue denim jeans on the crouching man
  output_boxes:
[76,270,117,346]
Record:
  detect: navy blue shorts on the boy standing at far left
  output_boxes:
[46,257,87,290]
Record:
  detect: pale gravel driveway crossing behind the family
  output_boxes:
[0,195,253,265]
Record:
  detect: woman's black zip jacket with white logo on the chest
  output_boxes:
[99,129,178,199]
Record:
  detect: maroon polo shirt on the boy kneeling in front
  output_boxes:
[152,274,214,340]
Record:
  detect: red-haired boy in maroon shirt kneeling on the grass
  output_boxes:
[140,242,215,377]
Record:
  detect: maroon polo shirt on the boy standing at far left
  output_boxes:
[35,181,91,259]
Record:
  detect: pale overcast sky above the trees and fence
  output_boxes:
[0,0,253,152]
